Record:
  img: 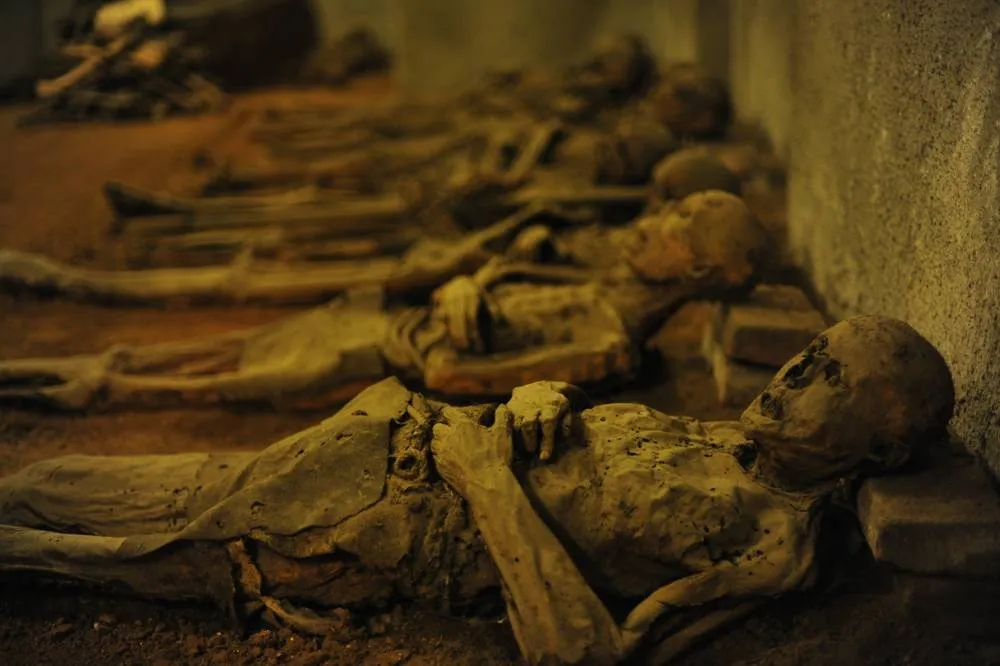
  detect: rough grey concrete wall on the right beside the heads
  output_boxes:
[732,0,1000,472]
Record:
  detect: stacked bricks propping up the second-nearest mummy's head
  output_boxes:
[702,285,826,407]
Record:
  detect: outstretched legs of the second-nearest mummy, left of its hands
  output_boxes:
[0,300,389,409]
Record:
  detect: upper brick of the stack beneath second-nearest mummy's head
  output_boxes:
[721,285,827,368]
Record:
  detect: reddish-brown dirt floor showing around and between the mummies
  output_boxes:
[0,82,1000,666]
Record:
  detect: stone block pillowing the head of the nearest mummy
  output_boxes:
[858,457,1000,577]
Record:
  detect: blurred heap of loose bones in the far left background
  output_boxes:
[20,19,224,125]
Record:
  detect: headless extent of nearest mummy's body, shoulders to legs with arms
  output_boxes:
[0,380,816,663]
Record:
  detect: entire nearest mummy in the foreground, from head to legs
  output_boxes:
[0,316,954,664]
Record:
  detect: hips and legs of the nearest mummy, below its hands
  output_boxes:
[0,380,497,622]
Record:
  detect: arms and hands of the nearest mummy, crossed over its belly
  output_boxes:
[432,382,800,664]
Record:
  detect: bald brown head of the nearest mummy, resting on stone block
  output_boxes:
[742,316,955,486]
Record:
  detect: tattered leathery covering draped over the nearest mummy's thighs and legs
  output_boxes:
[0,379,412,572]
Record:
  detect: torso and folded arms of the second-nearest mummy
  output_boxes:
[386,204,741,396]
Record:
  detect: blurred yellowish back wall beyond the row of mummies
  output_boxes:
[390,0,728,96]
